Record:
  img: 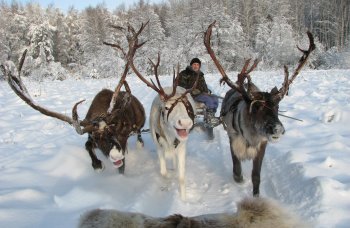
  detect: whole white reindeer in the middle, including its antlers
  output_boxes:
[113,25,198,200]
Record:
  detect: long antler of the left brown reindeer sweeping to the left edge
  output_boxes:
[1,50,95,133]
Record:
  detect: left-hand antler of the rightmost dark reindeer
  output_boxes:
[204,21,258,100]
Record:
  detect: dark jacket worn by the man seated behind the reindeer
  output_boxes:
[178,66,209,96]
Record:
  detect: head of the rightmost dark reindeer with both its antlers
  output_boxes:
[204,21,315,142]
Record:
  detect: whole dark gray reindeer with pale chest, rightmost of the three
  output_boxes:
[204,21,315,196]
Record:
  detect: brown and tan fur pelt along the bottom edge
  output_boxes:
[79,198,307,228]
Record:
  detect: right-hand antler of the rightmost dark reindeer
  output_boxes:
[276,31,316,100]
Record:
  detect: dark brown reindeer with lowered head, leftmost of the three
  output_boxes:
[1,23,147,173]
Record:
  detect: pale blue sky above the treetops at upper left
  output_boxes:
[6,0,163,11]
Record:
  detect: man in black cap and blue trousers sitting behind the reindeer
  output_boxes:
[178,58,220,127]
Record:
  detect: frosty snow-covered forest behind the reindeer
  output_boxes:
[0,0,350,80]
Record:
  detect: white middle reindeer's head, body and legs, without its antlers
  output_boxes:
[150,87,195,200]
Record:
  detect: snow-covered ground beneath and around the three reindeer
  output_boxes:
[0,70,350,228]
